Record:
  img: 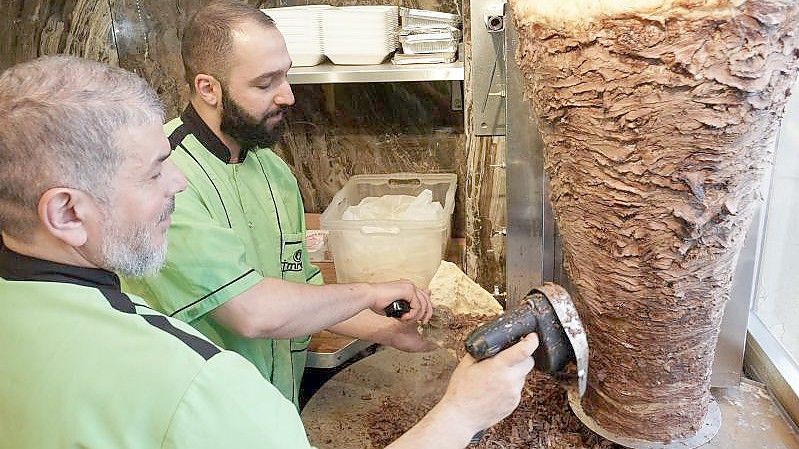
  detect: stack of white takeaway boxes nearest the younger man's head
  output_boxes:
[261,5,333,67]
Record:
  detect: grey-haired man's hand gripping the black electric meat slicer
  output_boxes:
[438,334,538,433]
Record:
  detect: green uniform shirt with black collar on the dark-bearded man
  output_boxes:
[125,105,322,404]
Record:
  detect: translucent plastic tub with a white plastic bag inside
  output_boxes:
[321,173,457,287]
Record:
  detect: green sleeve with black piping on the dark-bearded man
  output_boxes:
[125,185,263,322]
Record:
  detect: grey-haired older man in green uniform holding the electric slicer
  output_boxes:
[0,57,537,449]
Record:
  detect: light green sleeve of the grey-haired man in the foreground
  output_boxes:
[161,351,310,449]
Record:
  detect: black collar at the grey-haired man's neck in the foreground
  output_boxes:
[0,241,121,291]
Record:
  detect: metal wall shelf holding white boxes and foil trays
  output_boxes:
[288,61,463,84]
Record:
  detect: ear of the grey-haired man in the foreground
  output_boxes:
[37,187,98,247]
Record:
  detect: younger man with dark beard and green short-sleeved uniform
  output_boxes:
[121,1,438,402]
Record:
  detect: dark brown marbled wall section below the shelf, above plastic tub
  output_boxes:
[278,82,464,220]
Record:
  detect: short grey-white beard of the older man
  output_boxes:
[99,198,175,277]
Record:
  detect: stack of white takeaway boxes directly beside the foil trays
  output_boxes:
[322,6,399,65]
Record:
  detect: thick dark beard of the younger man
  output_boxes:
[220,88,288,151]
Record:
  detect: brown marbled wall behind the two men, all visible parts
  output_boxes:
[0,0,505,288]
